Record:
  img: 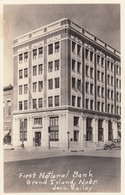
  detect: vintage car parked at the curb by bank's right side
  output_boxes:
[104,139,121,150]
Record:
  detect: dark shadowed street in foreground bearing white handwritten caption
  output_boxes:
[4,151,121,193]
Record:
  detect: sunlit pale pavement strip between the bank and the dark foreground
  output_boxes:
[4,147,121,162]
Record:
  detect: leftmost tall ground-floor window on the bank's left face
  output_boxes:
[20,119,27,141]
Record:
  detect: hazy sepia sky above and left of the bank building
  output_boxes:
[3,4,120,86]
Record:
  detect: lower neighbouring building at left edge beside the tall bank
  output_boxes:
[3,85,13,144]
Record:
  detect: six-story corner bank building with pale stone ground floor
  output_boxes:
[13,18,121,149]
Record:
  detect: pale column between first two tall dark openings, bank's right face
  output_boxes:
[92,118,98,144]
